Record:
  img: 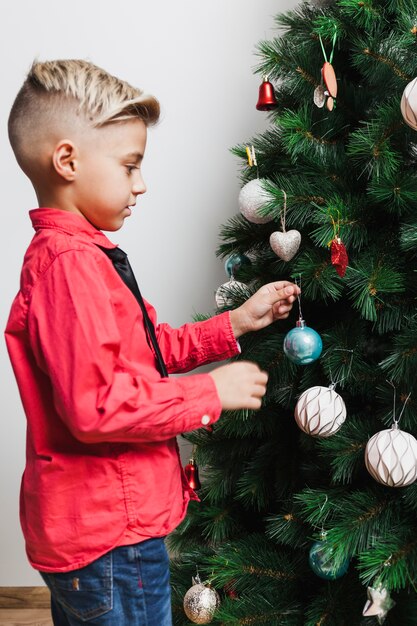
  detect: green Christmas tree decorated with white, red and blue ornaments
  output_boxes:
[170,0,417,626]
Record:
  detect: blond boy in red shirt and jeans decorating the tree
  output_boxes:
[6,60,299,626]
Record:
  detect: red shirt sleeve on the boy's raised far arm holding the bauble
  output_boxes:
[156,311,240,372]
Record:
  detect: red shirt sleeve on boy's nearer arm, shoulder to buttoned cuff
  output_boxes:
[28,250,221,443]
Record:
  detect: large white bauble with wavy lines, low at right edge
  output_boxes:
[365,424,417,487]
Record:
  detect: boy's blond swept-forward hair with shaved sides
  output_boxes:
[8,59,160,162]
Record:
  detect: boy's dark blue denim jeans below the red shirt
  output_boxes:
[41,539,172,626]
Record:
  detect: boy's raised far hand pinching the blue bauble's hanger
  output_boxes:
[230,280,300,338]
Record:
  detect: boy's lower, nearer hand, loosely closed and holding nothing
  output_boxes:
[210,361,268,410]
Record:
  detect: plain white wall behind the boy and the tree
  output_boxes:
[0,0,297,586]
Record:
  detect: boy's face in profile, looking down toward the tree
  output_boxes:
[72,119,147,231]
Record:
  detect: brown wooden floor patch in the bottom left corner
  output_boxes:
[0,587,52,626]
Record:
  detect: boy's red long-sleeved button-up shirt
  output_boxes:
[6,209,238,572]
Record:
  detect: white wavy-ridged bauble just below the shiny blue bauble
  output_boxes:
[294,386,346,437]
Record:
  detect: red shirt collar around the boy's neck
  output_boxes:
[29,207,117,249]
